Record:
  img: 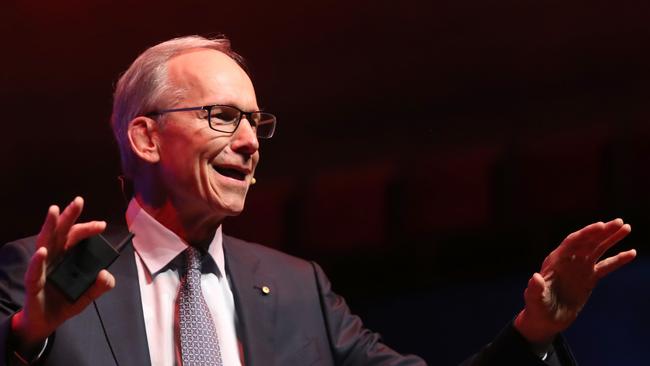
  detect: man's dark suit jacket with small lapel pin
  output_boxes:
[0,227,574,366]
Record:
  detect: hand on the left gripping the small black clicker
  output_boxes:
[11,197,115,349]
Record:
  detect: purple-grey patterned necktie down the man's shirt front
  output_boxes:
[176,246,223,366]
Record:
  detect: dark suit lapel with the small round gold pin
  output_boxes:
[223,235,277,366]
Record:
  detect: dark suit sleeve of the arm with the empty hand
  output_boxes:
[312,263,576,366]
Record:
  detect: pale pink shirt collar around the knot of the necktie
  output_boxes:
[126,198,225,276]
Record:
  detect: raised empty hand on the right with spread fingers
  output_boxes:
[514,219,636,344]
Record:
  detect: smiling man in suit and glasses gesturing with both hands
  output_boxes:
[0,37,636,365]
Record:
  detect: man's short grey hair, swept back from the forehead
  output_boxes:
[111,35,247,179]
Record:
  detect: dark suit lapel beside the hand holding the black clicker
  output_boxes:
[95,237,151,366]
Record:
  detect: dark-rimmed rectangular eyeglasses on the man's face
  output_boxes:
[146,104,277,139]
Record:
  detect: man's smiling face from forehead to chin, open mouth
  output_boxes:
[154,49,259,218]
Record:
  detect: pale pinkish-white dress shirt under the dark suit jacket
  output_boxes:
[126,199,241,366]
